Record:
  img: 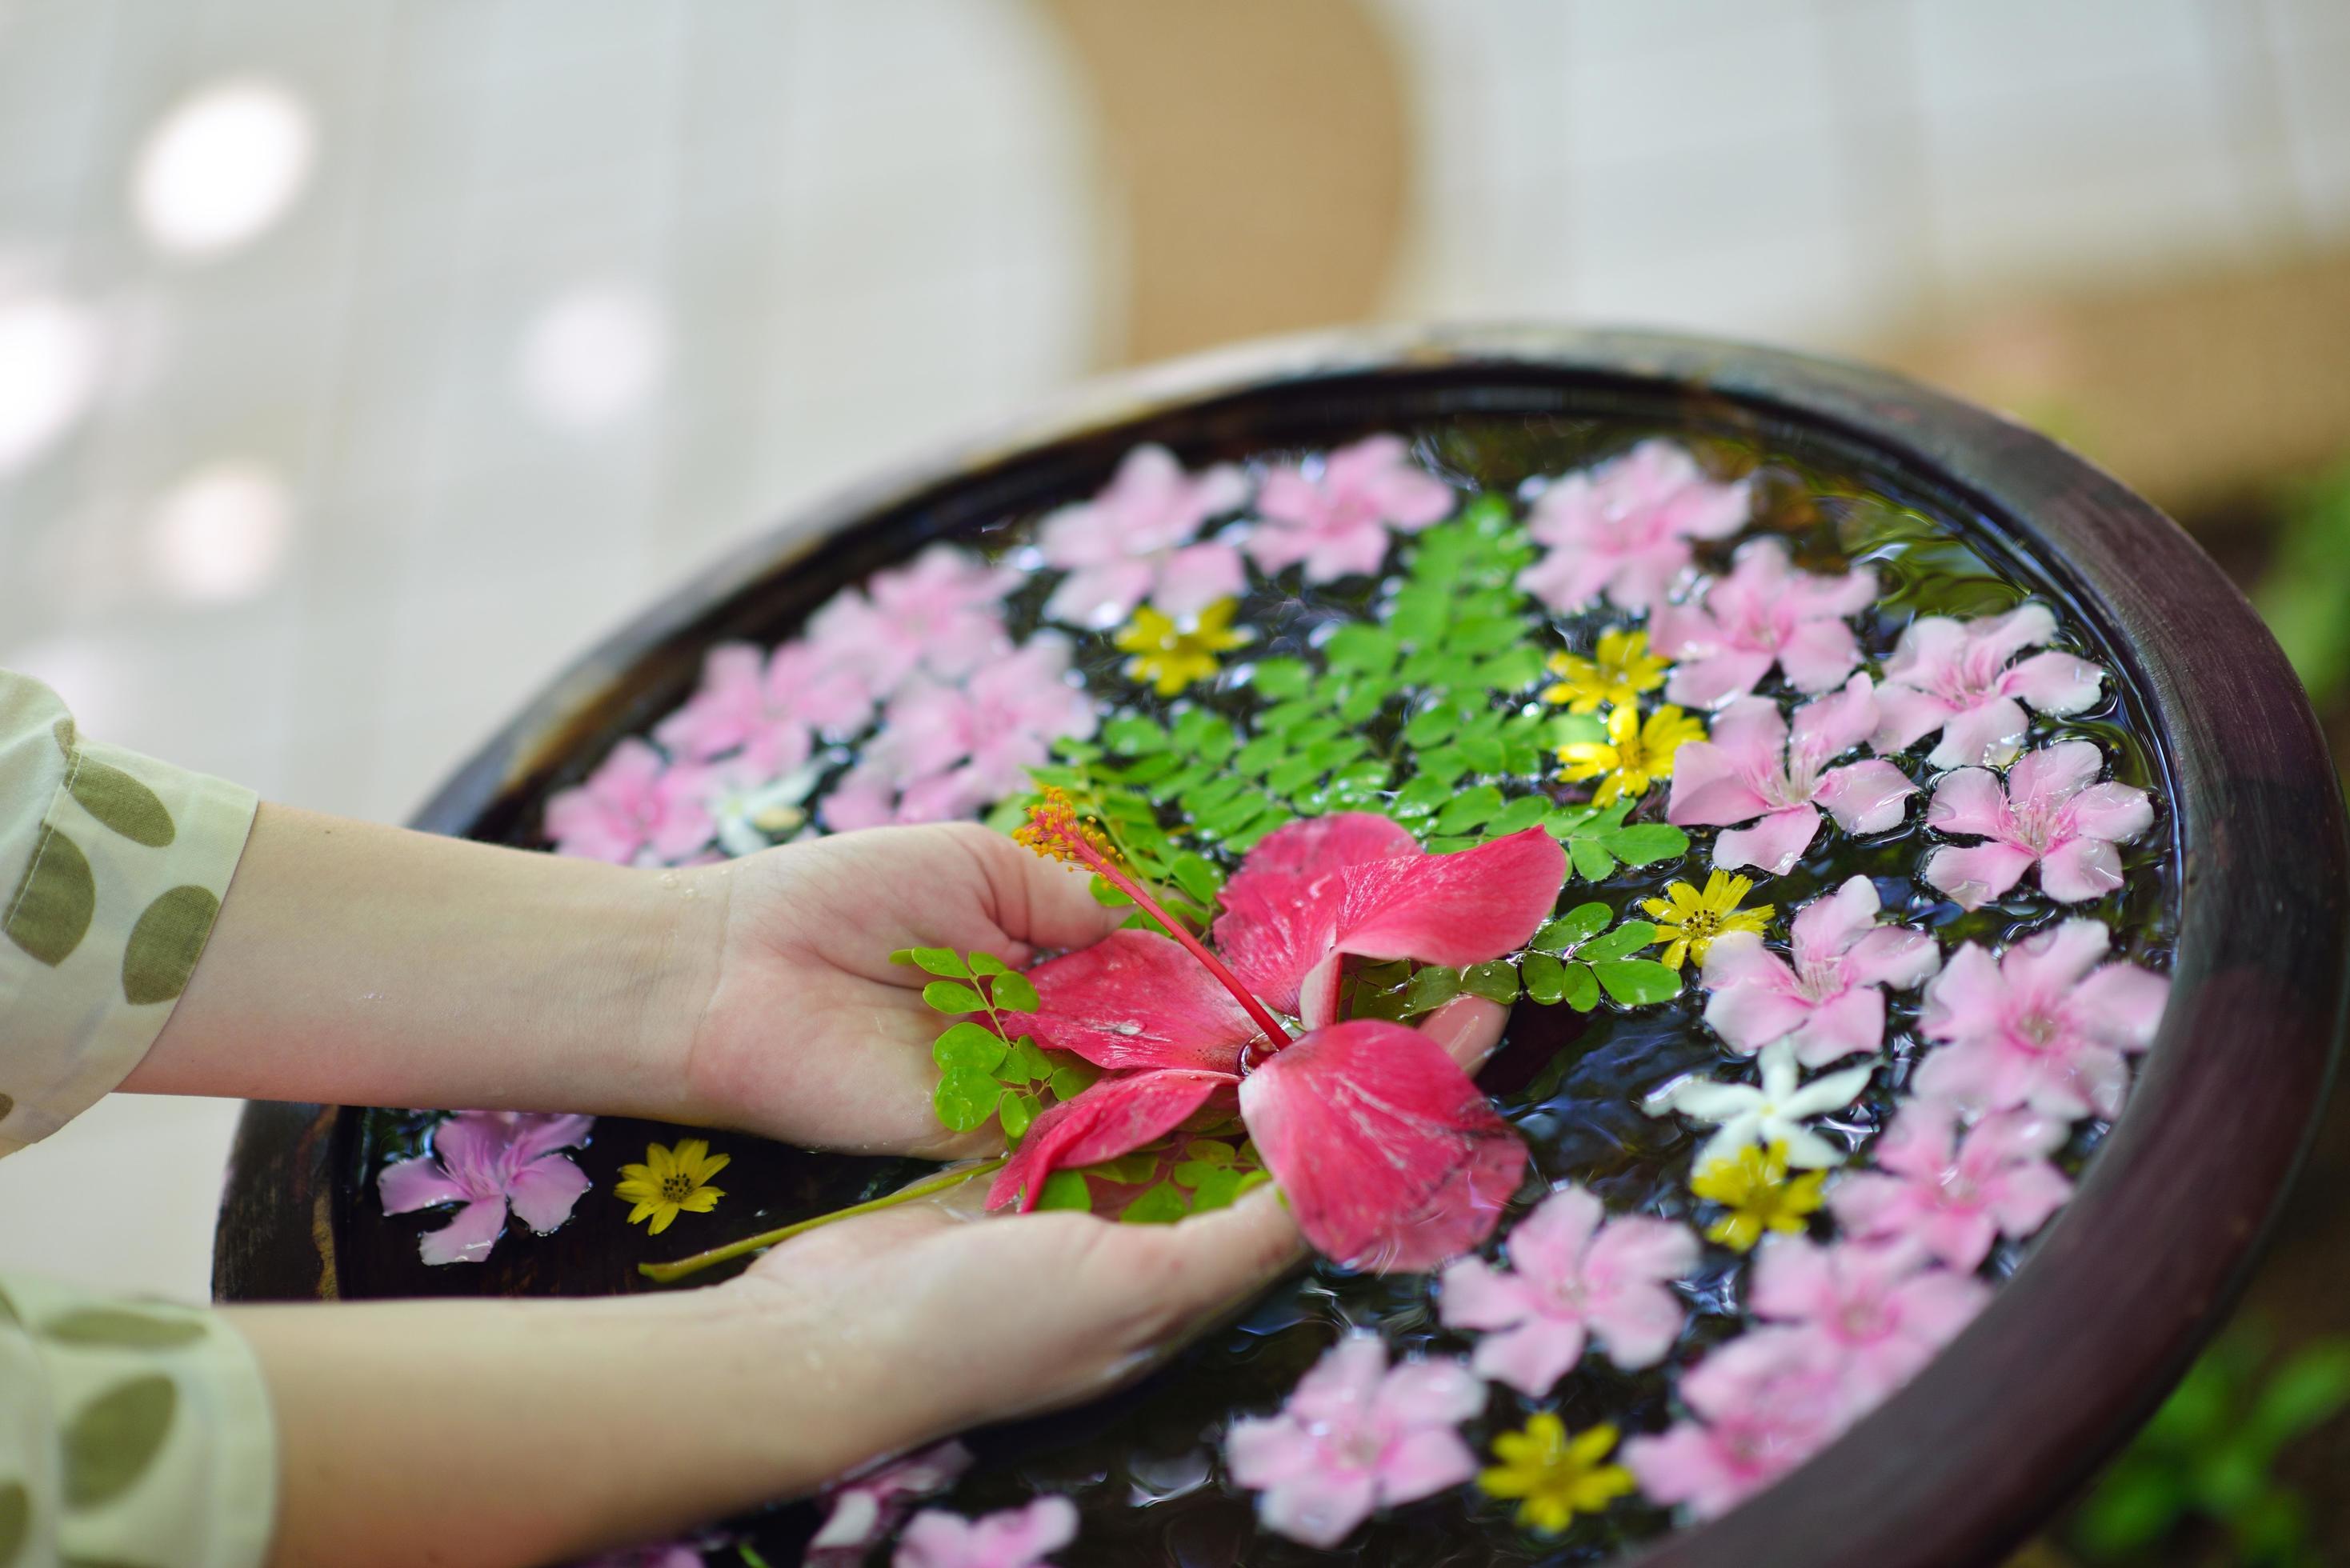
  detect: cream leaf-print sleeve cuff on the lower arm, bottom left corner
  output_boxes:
[0,1277,278,1568]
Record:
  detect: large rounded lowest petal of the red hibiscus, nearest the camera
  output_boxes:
[1240,1020,1525,1272]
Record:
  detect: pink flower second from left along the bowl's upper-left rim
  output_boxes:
[653,642,875,778]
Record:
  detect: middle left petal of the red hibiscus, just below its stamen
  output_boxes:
[1003,931,1259,1074]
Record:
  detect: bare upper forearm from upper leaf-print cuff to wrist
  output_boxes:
[122,806,724,1117]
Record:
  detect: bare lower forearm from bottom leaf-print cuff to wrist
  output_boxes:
[230,1286,893,1568]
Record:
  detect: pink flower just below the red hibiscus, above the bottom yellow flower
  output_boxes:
[1443,1187,1697,1398]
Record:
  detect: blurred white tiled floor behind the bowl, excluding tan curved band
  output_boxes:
[0,0,2350,1295]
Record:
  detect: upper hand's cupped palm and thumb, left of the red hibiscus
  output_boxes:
[687,822,1123,1159]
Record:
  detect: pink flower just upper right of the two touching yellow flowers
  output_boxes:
[1650,538,1878,707]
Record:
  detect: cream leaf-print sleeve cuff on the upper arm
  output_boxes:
[0,670,256,1154]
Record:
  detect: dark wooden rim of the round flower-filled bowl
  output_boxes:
[214,329,2350,1568]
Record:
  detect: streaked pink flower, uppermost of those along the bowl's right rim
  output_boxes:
[1876,604,2106,769]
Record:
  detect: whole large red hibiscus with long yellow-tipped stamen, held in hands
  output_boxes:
[987,794,1567,1270]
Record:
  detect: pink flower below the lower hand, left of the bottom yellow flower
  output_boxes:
[1224,1333,1485,1547]
